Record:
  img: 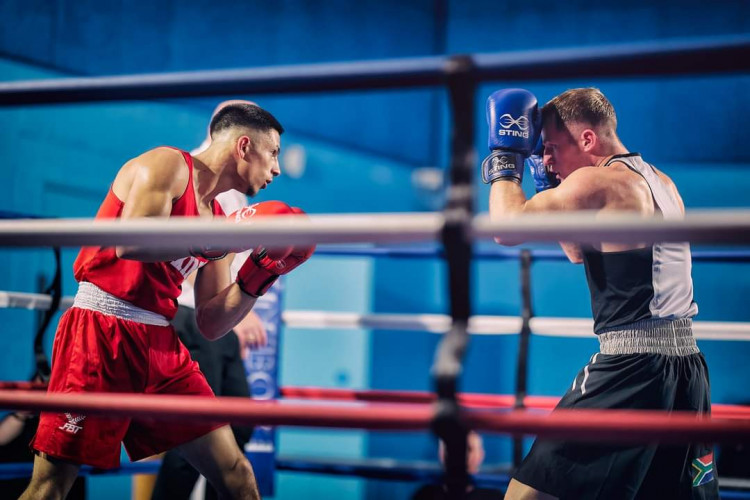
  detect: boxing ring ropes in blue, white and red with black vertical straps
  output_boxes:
[0,36,750,498]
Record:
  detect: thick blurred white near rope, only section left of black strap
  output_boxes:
[0,213,444,249]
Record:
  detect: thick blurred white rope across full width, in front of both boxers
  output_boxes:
[0,210,750,248]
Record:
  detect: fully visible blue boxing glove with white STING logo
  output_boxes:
[482,89,542,184]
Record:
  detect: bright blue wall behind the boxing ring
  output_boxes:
[0,0,750,500]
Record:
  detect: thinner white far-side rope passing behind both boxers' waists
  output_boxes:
[0,291,750,340]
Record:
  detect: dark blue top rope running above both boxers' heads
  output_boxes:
[0,34,750,106]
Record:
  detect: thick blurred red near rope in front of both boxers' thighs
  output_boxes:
[0,390,750,443]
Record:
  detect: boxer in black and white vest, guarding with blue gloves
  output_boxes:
[483,88,718,499]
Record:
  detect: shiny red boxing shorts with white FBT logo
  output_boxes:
[31,283,224,468]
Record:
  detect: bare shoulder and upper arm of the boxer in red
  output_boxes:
[112,149,189,262]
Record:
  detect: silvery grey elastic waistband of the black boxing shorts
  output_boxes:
[599,318,700,356]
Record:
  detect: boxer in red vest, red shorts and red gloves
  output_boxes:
[21,103,314,499]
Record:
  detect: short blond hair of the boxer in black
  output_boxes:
[542,87,617,130]
